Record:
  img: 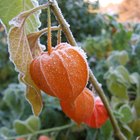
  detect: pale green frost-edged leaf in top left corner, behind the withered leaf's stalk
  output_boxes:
[0,0,40,33]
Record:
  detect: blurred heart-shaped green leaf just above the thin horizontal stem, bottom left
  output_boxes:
[14,116,40,135]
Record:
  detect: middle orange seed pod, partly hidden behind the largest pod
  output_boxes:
[60,88,94,124]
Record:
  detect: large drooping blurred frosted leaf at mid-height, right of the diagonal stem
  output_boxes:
[104,65,131,99]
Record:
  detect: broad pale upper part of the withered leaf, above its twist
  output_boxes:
[8,26,33,74]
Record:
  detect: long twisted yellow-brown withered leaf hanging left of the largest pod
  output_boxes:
[8,22,42,115]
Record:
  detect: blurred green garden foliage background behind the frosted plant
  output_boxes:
[0,0,140,140]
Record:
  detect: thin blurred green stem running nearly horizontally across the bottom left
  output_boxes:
[6,123,74,140]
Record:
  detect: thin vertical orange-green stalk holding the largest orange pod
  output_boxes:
[48,6,52,54]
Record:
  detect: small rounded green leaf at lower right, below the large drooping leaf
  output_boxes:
[119,105,133,123]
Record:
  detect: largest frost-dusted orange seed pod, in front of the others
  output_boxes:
[30,43,88,101]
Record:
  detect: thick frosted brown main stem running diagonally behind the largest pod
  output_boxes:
[50,0,127,140]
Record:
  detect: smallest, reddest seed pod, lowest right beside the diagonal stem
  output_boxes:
[84,97,109,128]
